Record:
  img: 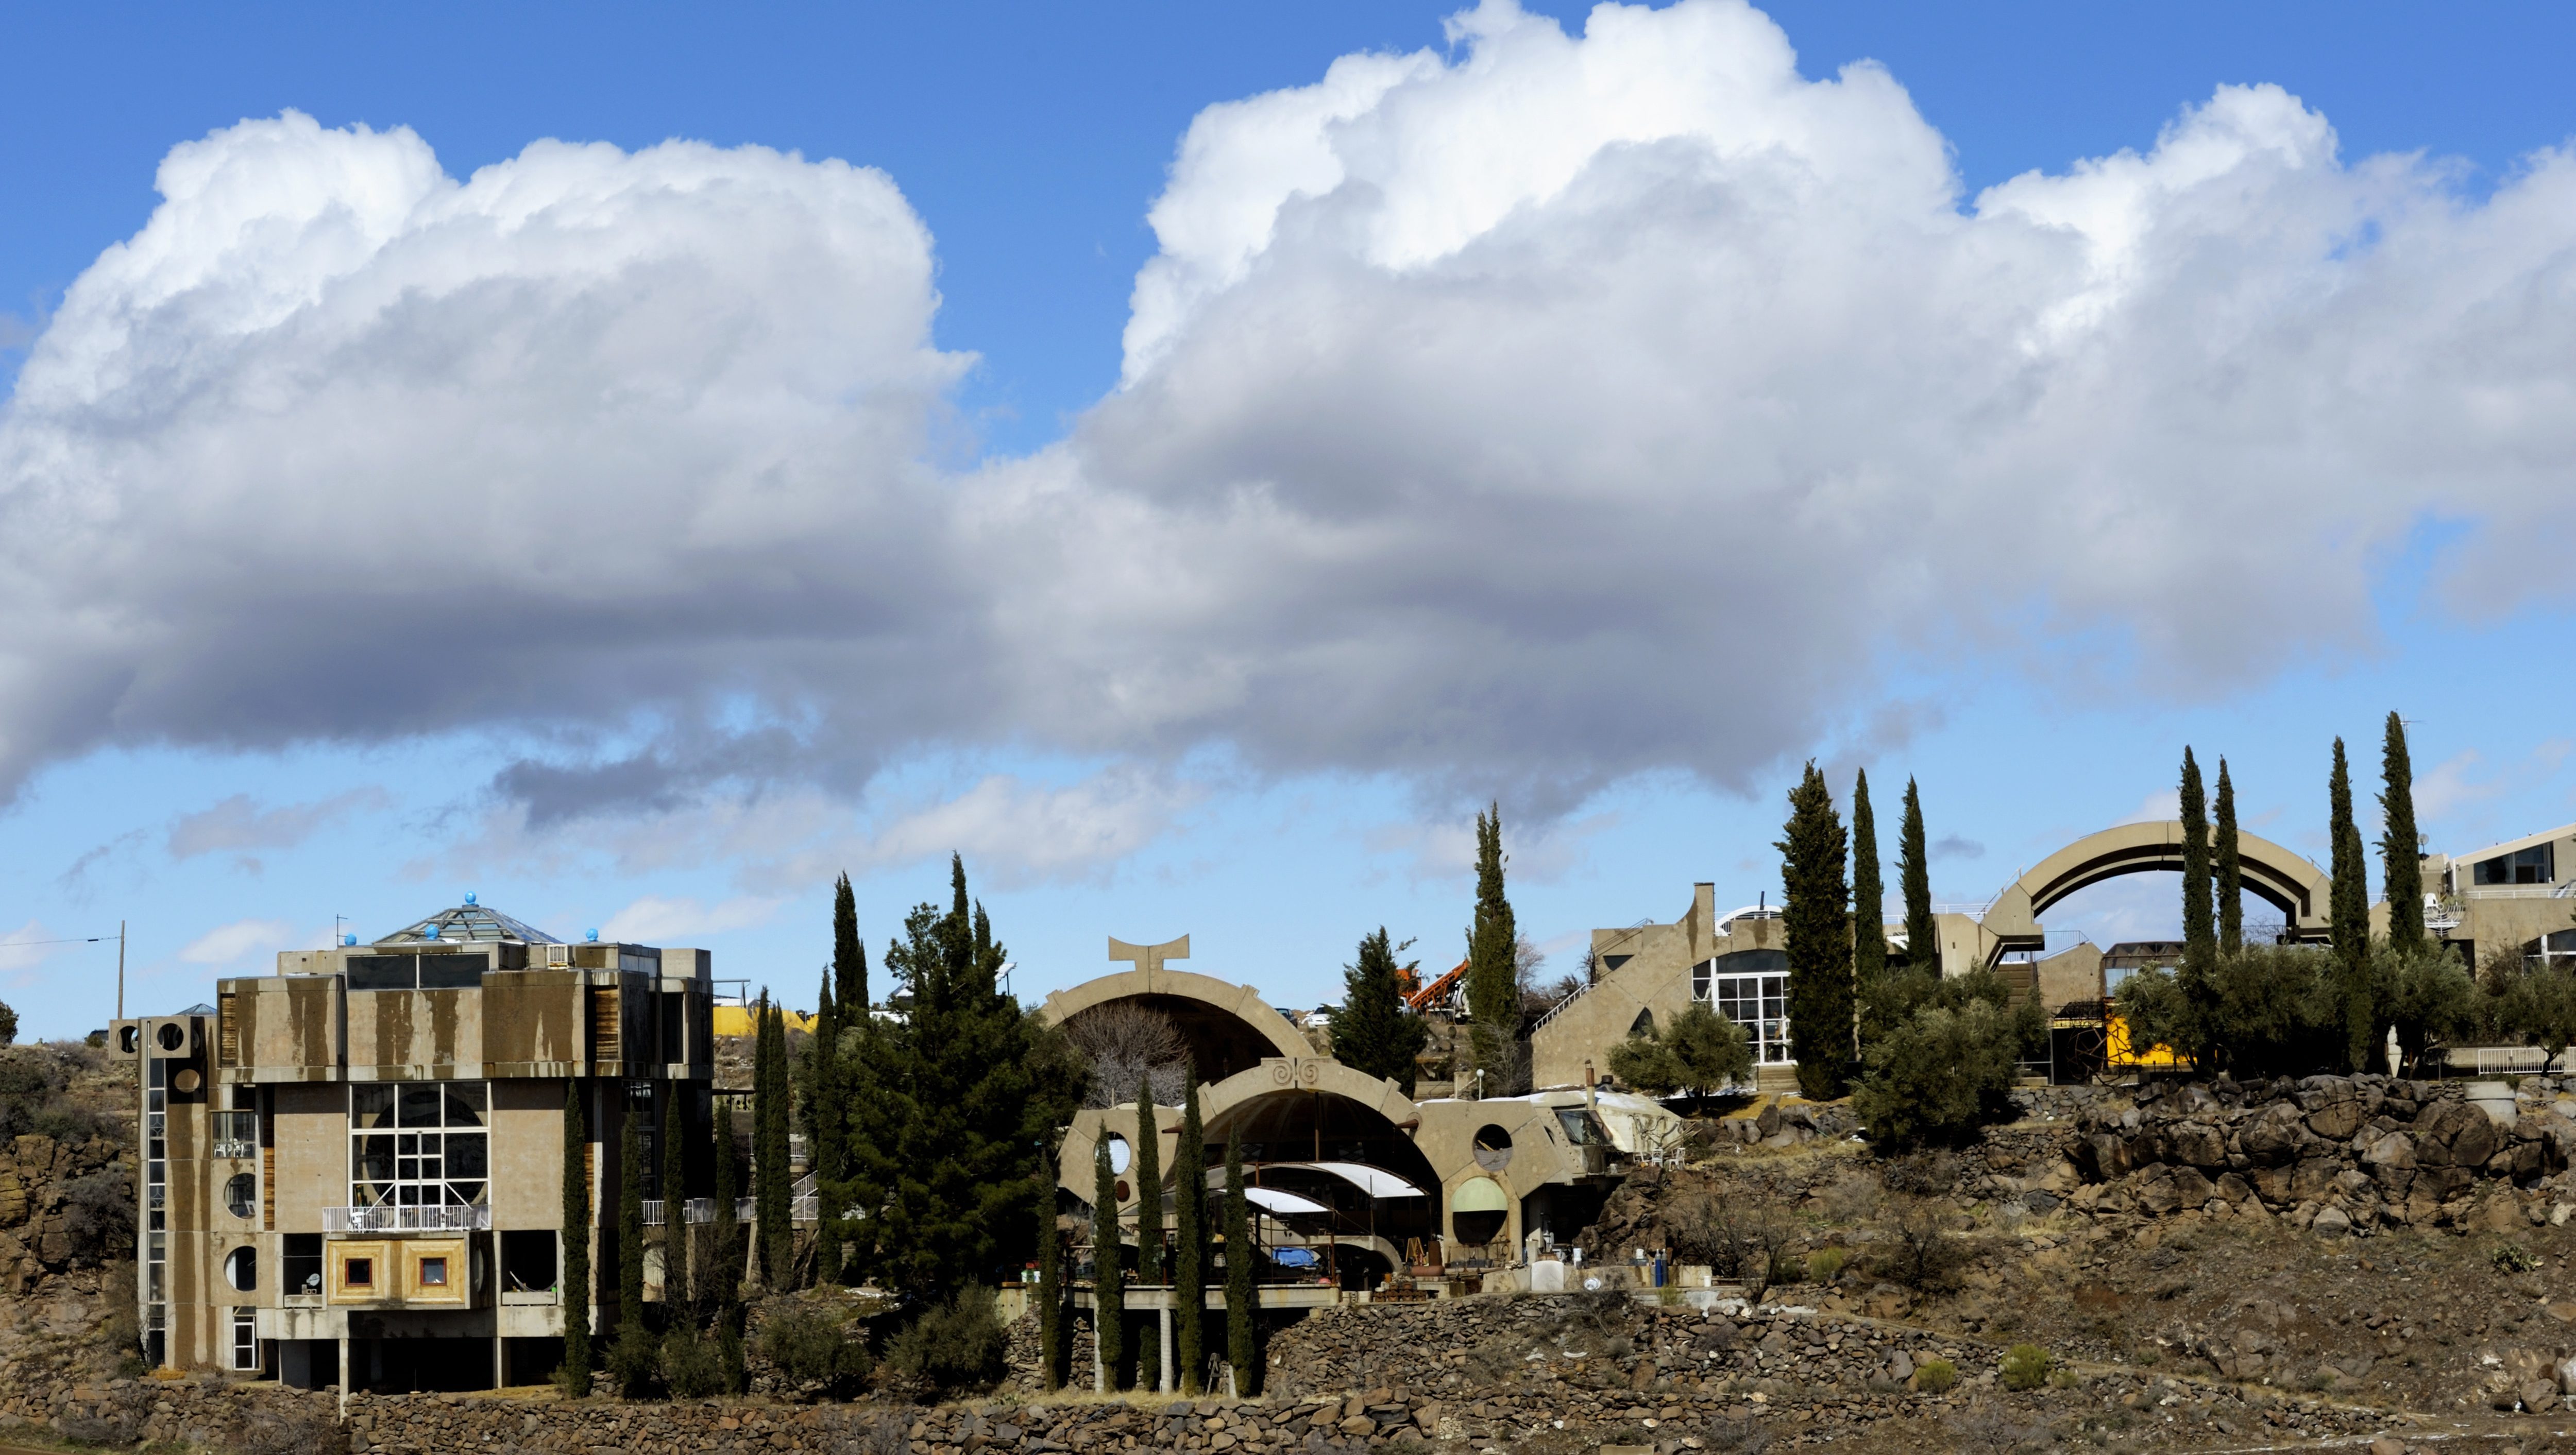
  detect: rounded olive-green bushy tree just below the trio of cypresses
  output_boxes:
[1852,968,2048,1146]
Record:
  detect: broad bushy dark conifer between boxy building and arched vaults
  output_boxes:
[842,858,1084,1298]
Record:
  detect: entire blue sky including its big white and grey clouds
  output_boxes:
[0,5,2576,1035]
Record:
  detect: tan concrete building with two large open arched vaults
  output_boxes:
[1041,937,1680,1288]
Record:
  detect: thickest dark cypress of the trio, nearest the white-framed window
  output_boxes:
[1772,760,1852,1102]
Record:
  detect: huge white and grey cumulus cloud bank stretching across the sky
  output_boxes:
[0,0,2576,842]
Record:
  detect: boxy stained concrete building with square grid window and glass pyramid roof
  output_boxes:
[111,896,714,1391]
